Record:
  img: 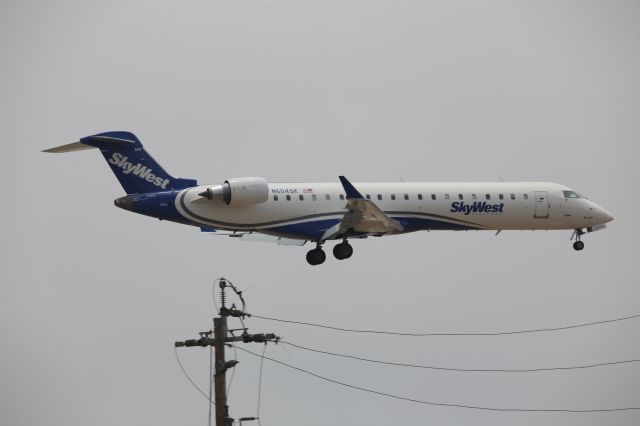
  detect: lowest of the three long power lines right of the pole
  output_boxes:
[238,347,640,413]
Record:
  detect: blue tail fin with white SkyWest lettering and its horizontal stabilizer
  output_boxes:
[47,132,198,194]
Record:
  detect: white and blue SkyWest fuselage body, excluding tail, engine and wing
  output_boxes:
[175,182,612,240]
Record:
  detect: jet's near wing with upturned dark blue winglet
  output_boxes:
[322,176,403,240]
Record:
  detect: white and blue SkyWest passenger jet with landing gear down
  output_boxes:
[43,131,613,265]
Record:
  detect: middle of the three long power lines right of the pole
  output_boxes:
[280,340,640,373]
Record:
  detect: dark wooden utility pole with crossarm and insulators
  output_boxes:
[175,278,280,426]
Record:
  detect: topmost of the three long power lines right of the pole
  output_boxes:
[247,314,640,337]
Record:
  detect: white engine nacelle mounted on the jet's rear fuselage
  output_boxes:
[198,177,269,206]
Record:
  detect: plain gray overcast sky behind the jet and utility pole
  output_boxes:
[0,0,640,426]
